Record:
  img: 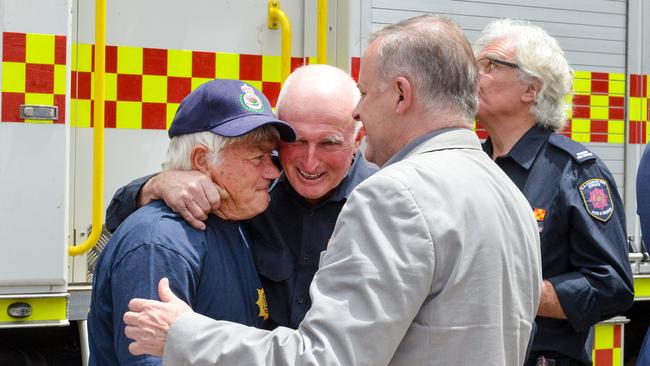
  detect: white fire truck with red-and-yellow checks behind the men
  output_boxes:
[0,0,650,365]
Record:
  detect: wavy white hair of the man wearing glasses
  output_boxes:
[475,19,573,131]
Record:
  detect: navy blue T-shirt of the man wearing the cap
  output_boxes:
[88,201,268,365]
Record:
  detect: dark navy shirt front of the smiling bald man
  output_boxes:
[245,152,376,329]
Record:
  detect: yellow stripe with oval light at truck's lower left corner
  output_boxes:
[0,297,68,323]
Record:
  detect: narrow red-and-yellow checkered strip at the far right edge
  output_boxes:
[628,74,650,144]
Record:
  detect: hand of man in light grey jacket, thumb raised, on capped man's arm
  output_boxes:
[124,278,192,357]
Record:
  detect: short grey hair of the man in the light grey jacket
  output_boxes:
[369,15,478,123]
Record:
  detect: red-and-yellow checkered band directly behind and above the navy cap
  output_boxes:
[71,44,312,129]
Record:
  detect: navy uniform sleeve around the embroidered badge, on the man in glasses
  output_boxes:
[548,162,634,331]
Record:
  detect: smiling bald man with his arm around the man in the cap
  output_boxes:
[106,65,376,328]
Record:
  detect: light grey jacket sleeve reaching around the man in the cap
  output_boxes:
[163,175,434,366]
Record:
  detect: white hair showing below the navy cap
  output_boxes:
[162,125,280,170]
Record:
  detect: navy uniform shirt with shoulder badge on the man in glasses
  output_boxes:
[484,126,633,363]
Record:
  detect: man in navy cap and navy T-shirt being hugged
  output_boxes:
[88,80,295,365]
